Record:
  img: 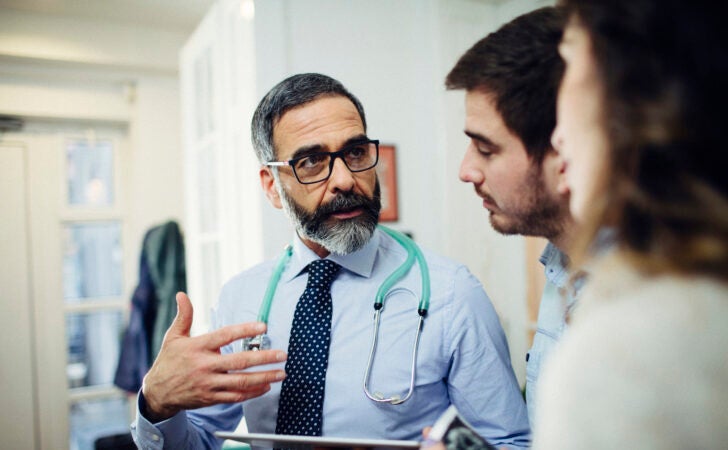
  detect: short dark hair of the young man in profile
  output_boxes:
[445,7,565,163]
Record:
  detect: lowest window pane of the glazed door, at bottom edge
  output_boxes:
[70,398,131,450]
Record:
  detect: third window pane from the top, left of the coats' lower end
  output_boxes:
[66,311,123,388]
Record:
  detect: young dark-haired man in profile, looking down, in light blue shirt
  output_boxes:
[445,7,574,428]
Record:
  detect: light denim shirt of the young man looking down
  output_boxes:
[526,242,581,427]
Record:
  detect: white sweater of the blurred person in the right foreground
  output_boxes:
[533,256,728,450]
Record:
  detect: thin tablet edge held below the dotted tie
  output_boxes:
[215,431,420,450]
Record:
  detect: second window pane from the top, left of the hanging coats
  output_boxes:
[63,222,122,303]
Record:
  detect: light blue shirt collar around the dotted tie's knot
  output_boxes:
[281,229,381,281]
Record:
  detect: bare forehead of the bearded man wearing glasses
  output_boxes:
[273,96,364,159]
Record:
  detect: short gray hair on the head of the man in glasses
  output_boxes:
[250,73,367,164]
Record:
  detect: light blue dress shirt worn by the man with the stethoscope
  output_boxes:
[132,230,530,449]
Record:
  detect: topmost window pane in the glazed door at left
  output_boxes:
[66,139,114,206]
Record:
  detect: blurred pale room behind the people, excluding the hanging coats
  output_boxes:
[0,0,553,450]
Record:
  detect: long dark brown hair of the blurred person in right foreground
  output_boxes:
[562,0,728,280]
